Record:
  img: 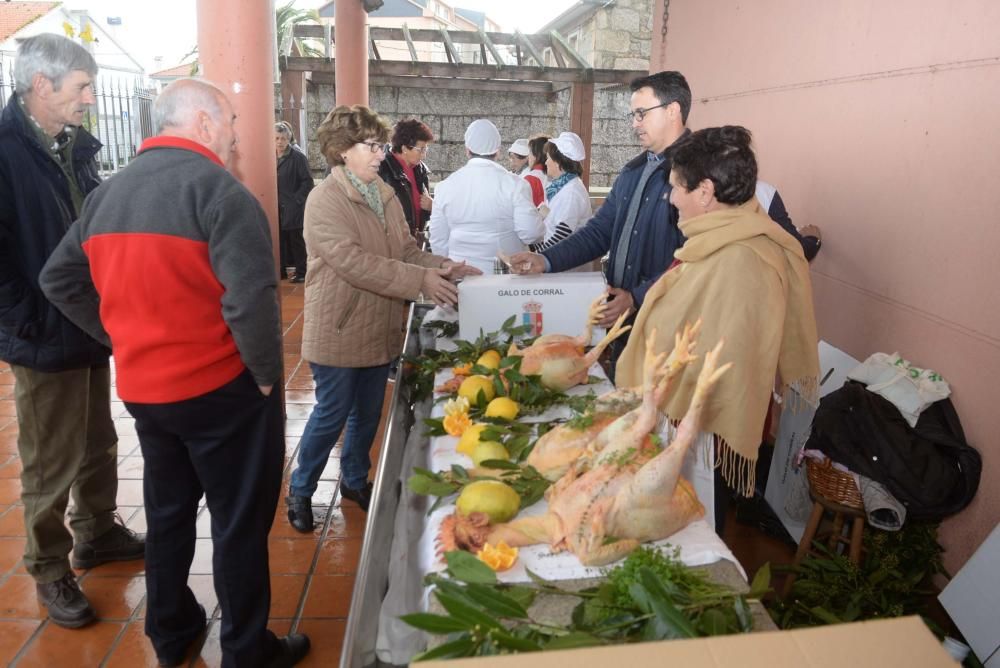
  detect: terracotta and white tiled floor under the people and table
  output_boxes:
[0,282,794,668]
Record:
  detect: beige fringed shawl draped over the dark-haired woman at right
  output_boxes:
[616,198,819,496]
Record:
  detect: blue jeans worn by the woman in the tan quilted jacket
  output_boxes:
[289,363,389,497]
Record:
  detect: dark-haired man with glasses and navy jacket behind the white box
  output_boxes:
[510,72,691,368]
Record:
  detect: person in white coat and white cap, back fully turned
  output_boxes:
[430,118,545,274]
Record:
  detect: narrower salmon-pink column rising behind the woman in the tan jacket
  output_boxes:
[333,0,368,106]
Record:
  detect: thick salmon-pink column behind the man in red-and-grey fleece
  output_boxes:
[198,0,278,270]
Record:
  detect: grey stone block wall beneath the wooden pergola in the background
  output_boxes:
[307,85,639,187]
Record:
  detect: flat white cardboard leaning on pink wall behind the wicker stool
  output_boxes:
[764,341,859,542]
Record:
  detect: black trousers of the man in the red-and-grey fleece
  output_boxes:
[126,371,284,668]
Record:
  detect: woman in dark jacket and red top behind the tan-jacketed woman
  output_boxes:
[378,118,434,242]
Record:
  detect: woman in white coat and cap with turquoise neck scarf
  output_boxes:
[531,132,592,254]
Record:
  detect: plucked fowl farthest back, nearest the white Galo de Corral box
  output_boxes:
[507,300,631,391]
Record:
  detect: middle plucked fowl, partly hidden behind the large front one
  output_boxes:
[527,324,699,481]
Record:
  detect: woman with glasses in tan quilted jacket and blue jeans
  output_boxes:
[287,105,478,532]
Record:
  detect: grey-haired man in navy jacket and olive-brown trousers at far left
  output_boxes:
[0,34,143,628]
